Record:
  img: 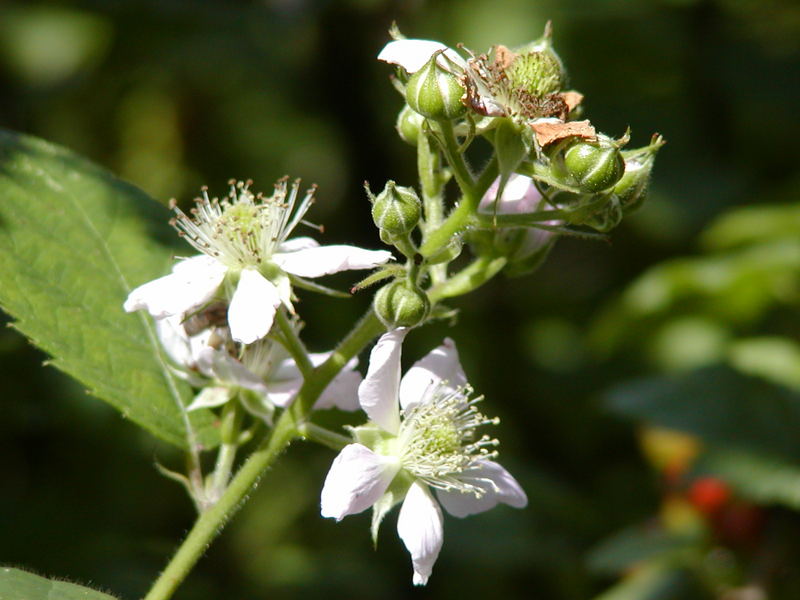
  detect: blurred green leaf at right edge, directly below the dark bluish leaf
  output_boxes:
[695,448,800,510]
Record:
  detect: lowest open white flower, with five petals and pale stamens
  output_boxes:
[321,329,528,585]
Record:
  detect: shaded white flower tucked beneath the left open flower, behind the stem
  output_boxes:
[188,339,361,422]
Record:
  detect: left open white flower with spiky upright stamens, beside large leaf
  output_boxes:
[124,179,392,344]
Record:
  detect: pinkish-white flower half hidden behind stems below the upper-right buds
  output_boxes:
[478,173,564,261]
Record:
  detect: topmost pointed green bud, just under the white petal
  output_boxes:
[406,52,467,121]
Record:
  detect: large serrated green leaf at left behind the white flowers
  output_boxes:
[0,130,217,447]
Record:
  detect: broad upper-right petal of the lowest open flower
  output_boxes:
[400,338,467,410]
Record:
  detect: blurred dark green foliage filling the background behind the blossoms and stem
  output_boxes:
[0,0,800,600]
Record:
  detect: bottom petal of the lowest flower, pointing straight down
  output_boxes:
[397,481,444,585]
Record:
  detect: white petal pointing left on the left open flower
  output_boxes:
[123,255,227,319]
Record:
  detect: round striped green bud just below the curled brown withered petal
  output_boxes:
[551,135,627,193]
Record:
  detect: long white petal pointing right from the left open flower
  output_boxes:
[272,245,392,277]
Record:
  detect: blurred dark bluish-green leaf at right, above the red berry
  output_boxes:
[608,367,800,458]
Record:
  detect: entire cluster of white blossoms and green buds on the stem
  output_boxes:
[124,21,663,585]
